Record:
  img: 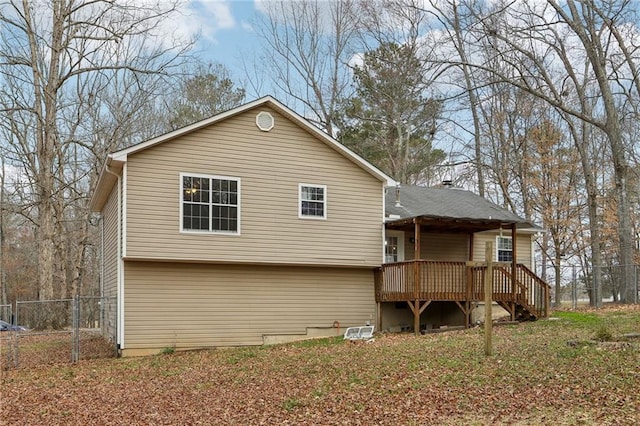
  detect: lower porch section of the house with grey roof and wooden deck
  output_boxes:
[376,185,549,331]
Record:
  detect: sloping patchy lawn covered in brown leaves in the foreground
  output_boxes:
[0,306,640,425]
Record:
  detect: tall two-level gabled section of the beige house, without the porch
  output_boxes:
[91,97,393,355]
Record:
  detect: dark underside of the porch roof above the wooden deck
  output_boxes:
[385,216,531,234]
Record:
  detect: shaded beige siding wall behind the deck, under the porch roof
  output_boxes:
[404,232,469,262]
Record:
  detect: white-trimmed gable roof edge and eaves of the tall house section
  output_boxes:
[90,96,395,211]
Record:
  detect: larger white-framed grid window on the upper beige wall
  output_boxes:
[180,174,240,234]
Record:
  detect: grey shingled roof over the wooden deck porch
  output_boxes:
[386,186,542,232]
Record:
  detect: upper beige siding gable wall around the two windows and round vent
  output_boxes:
[126,108,383,266]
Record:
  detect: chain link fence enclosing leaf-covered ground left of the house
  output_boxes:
[0,297,117,369]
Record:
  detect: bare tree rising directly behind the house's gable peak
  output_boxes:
[247,0,357,136]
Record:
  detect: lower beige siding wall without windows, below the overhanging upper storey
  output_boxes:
[124,262,376,350]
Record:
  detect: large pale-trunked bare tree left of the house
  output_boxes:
[0,0,194,306]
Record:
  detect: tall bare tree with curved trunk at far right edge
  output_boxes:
[448,0,640,301]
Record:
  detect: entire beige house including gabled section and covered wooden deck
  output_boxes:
[91,97,546,356]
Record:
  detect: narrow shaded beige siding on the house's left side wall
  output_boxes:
[102,185,119,336]
